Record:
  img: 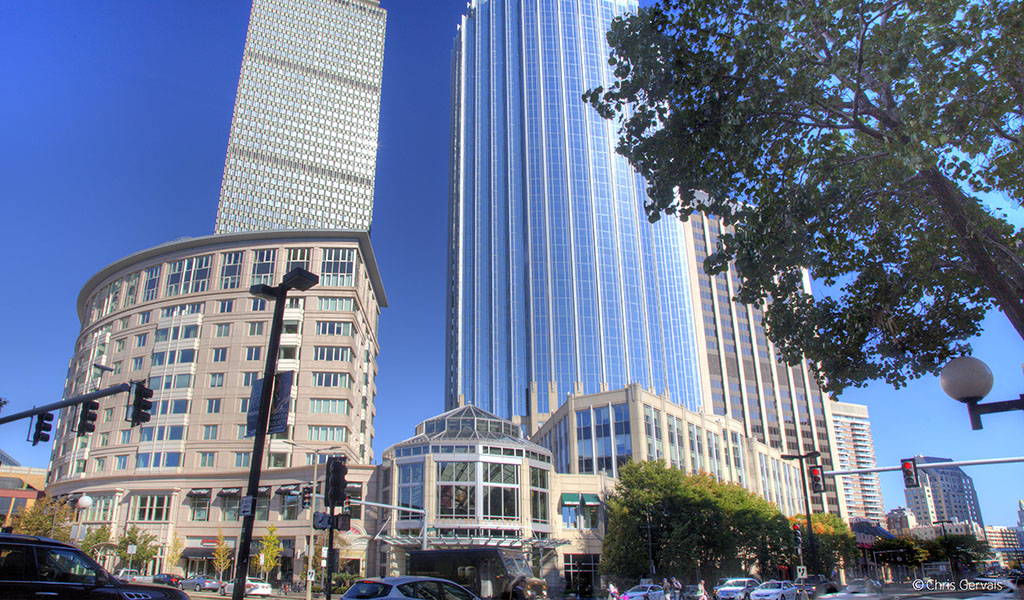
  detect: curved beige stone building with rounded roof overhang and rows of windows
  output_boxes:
[47,230,387,578]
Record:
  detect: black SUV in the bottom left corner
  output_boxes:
[0,533,188,600]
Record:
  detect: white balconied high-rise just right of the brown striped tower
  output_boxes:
[831,402,886,525]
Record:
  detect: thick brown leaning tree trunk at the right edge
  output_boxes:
[922,168,1024,338]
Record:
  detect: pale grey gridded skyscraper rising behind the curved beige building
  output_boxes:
[216,0,385,233]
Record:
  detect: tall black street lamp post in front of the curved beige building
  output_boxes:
[231,267,319,600]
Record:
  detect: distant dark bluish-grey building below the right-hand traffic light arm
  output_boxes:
[905,457,985,526]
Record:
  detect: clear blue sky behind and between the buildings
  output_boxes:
[0,0,1024,525]
